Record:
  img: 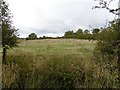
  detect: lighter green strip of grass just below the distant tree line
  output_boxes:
[19,39,95,55]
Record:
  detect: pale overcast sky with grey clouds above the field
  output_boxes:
[7,0,118,37]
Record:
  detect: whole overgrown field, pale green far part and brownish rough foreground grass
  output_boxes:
[2,39,118,88]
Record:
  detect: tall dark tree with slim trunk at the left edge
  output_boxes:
[0,1,18,64]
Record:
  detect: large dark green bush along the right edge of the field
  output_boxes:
[94,21,120,87]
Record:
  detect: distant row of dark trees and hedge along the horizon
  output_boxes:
[26,28,100,40]
